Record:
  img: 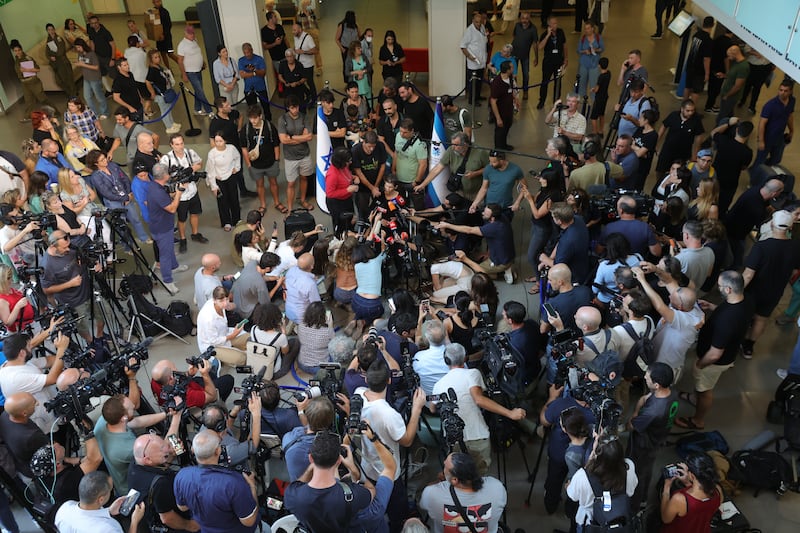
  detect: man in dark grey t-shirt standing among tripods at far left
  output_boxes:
[41,229,103,343]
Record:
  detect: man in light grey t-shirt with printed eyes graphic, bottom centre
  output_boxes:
[419,453,508,533]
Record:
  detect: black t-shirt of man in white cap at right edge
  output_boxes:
[744,239,800,308]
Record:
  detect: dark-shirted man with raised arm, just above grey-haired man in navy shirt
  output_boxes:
[201,392,261,468]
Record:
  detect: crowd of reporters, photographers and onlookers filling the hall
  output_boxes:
[0,0,800,532]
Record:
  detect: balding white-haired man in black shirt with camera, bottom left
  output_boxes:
[128,433,200,533]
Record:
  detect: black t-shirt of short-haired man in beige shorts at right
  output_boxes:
[697,297,753,365]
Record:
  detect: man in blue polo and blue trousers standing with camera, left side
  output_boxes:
[147,163,189,295]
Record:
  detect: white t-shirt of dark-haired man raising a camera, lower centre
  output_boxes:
[356,387,406,479]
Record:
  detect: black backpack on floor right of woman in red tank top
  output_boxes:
[728,450,793,497]
